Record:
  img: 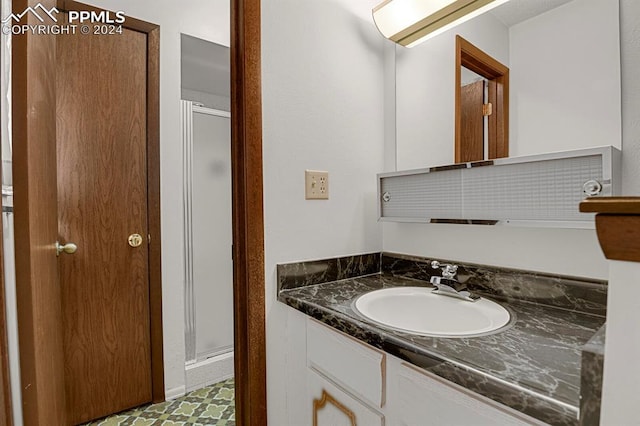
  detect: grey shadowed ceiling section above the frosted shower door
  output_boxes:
[180,34,231,97]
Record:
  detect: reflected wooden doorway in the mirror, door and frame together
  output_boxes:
[455,36,509,163]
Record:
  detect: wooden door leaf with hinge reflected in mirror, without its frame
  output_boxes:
[460,80,484,162]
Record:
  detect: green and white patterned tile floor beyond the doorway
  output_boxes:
[86,379,236,426]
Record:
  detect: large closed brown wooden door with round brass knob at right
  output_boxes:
[57,11,152,424]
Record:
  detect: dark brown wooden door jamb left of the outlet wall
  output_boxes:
[231,0,267,426]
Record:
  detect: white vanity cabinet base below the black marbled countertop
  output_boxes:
[306,319,544,426]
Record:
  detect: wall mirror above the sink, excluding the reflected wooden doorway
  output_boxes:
[395,0,622,170]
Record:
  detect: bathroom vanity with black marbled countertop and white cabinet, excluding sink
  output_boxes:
[278,253,607,425]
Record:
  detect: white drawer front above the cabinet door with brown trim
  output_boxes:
[307,319,386,407]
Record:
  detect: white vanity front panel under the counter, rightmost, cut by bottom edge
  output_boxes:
[397,363,543,426]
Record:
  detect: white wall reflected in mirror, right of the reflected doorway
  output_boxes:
[509,0,622,156]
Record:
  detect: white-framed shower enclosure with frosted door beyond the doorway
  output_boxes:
[181,101,233,391]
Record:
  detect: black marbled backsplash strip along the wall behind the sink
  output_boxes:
[278,253,607,316]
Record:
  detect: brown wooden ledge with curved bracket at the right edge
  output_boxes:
[580,197,640,262]
